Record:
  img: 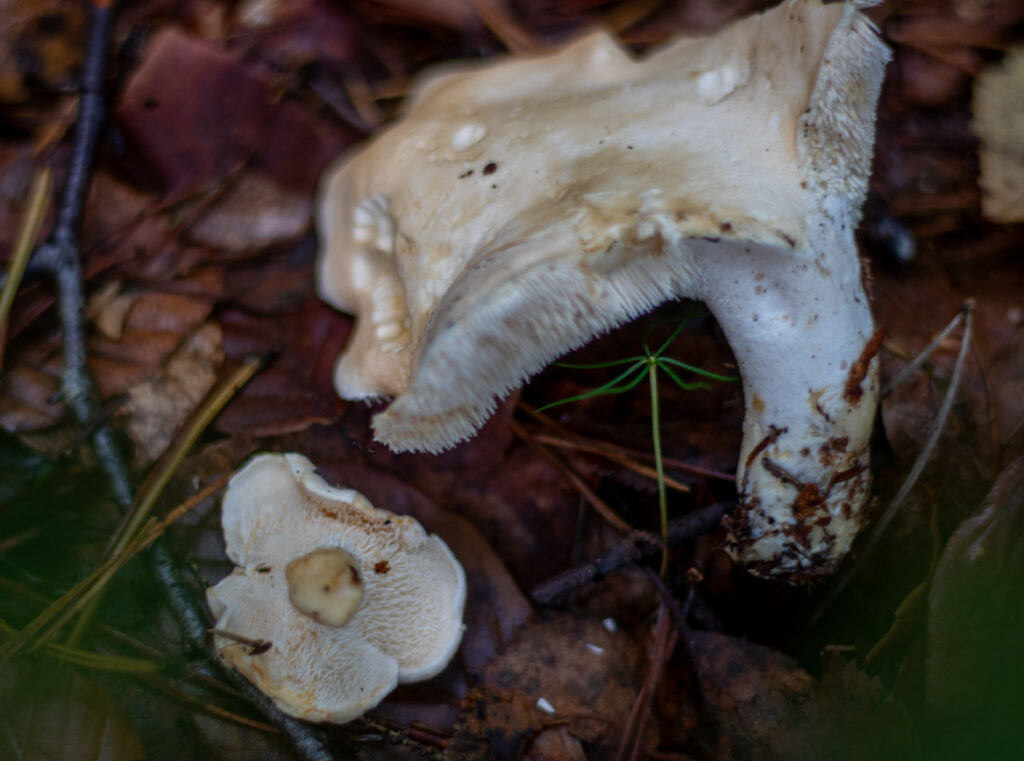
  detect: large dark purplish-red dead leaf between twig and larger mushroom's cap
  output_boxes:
[116,27,351,203]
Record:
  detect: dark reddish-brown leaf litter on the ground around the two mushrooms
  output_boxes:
[0,0,1024,761]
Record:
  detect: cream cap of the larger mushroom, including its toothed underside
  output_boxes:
[317,0,886,452]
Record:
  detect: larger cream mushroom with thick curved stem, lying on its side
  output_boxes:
[318,0,888,577]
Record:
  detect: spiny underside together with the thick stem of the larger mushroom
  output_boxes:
[373,226,878,580]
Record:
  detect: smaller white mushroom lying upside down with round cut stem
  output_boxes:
[207,455,466,722]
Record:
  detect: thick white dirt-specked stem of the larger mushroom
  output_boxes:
[696,210,878,578]
